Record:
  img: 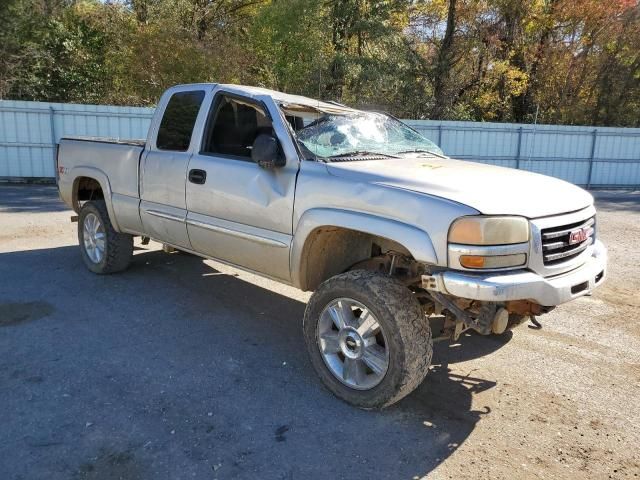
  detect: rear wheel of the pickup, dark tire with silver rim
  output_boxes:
[78,200,133,275]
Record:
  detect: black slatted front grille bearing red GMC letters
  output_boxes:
[541,217,596,265]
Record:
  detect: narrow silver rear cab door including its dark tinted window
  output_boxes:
[140,86,210,248]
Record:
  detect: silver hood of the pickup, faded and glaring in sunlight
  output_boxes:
[327,156,593,218]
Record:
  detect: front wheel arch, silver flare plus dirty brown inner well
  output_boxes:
[290,208,438,291]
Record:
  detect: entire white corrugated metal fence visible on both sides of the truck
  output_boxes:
[0,100,640,188]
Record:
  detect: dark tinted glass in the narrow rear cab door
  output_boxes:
[156,90,204,152]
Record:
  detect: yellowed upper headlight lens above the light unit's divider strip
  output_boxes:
[449,217,529,245]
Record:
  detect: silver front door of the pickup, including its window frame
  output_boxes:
[186,87,299,281]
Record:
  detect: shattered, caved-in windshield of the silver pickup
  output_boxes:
[296,112,442,158]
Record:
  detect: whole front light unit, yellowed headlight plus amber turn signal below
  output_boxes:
[449,216,529,270]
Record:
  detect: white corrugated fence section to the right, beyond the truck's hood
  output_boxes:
[407,120,640,188]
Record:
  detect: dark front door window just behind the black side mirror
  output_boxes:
[202,95,274,160]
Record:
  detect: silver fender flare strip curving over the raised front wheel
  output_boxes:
[290,208,438,288]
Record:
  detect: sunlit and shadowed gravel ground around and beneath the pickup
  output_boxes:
[0,185,640,480]
